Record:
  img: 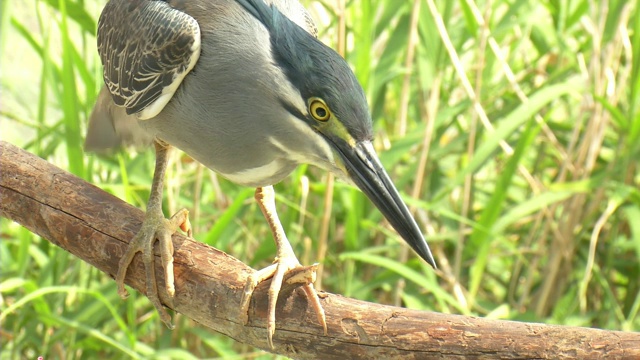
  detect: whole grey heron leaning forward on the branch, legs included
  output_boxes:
[85,0,436,348]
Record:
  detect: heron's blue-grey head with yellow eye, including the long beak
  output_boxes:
[238,0,436,268]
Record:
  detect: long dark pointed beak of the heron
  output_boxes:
[334,141,436,268]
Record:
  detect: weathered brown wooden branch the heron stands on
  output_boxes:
[0,142,640,359]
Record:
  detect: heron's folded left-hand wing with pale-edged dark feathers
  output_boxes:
[98,0,200,119]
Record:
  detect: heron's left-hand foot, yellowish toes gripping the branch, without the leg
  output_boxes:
[116,209,191,329]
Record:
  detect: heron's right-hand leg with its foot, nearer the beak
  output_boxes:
[240,186,327,349]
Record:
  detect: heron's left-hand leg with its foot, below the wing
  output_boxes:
[116,141,191,329]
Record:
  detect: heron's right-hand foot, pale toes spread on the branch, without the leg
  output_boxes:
[240,254,327,349]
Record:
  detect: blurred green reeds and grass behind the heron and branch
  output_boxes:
[0,0,640,359]
